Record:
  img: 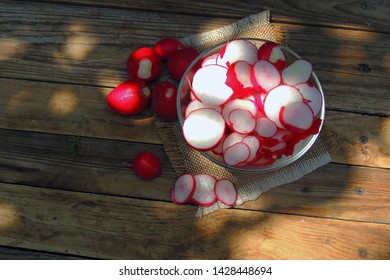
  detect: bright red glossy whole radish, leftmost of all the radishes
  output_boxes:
[106,80,150,115]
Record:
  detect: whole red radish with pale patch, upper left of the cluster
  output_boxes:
[127,47,162,83]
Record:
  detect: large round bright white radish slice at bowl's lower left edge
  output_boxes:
[183,108,225,150]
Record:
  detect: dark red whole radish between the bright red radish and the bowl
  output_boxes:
[150,81,178,121]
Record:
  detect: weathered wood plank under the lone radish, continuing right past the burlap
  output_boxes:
[0,129,390,223]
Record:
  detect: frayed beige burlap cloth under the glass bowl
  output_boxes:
[155,11,331,217]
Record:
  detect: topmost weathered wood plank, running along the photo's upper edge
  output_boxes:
[32,0,390,32]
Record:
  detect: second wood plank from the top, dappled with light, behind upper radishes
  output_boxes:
[0,2,390,86]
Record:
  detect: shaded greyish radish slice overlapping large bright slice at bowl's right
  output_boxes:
[280,102,314,133]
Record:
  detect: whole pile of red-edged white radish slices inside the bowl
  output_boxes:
[182,39,323,167]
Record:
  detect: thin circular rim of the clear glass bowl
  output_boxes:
[176,37,325,173]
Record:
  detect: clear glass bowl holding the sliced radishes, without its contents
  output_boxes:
[177,38,325,172]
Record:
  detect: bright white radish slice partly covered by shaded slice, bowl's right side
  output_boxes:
[264,85,303,128]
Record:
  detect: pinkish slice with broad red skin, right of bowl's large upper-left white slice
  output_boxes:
[225,60,256,98]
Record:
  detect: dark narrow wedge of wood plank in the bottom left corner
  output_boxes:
[0,246,83,260]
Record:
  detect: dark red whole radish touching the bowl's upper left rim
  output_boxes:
[167,47,201,81]
